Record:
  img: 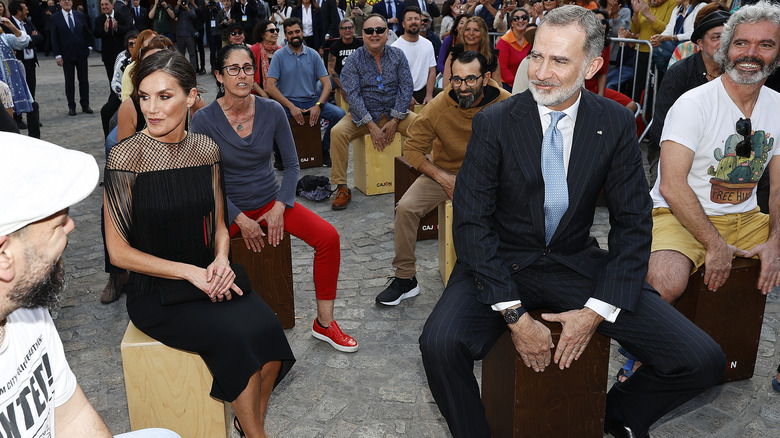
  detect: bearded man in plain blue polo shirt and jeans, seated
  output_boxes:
[266,17,347,167]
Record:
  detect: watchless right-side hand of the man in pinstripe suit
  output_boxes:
[542,307,604,369]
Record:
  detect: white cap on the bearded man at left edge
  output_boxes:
[0,132,100,236]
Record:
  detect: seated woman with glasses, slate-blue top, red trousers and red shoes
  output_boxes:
[192,45,358,352]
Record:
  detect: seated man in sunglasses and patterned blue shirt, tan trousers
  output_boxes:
[330,14,414,210]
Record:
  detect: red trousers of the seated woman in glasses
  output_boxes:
[230,200,341,300]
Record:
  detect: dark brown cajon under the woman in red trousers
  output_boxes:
[230,233,295,329]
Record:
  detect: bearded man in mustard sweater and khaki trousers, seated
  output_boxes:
[376,52,511,306]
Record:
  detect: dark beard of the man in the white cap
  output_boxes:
[10,248,65,310]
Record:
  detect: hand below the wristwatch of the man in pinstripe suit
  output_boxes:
[508,313,555,373]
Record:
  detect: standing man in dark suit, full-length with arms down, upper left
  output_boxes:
[51,0,93,116]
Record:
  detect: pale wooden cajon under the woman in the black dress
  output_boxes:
[121,322,233,438]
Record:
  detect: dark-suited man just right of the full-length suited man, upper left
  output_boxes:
[92,0,133,84]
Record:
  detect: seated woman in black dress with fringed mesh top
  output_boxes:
[104,51,295,438]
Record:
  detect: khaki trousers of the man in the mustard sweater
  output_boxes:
[393,175,449,278]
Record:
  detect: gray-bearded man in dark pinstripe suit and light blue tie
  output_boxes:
[420,6,726,438]
